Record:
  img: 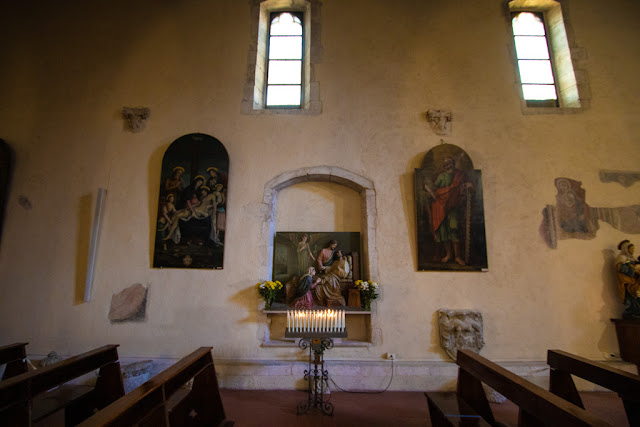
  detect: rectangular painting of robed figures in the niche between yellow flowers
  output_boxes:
[273,232,361,309]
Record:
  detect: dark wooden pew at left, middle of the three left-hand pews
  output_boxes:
[0,345,124,426]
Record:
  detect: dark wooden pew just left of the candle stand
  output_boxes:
[80,347,233,427]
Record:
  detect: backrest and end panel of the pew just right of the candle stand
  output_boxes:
[457,350,610,426]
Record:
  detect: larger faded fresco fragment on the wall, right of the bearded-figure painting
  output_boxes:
[540,178,640,248]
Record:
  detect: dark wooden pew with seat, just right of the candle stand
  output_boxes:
[425,350,610,426]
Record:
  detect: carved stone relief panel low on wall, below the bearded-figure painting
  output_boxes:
[438,309,484,360]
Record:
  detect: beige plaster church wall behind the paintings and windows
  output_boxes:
[0,0,640,368]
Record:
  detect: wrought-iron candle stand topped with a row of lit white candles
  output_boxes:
[284,310,347,415]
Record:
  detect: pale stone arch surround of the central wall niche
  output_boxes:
[263,166,379,281]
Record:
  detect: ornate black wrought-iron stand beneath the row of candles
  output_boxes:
[297,337,333,415]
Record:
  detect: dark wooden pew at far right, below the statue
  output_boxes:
[547,350,640,426]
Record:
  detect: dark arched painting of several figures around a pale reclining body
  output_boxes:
[153,133,229,269]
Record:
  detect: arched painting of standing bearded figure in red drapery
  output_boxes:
[415,144,487,271]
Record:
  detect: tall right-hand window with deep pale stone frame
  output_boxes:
[508,0,589,114]
